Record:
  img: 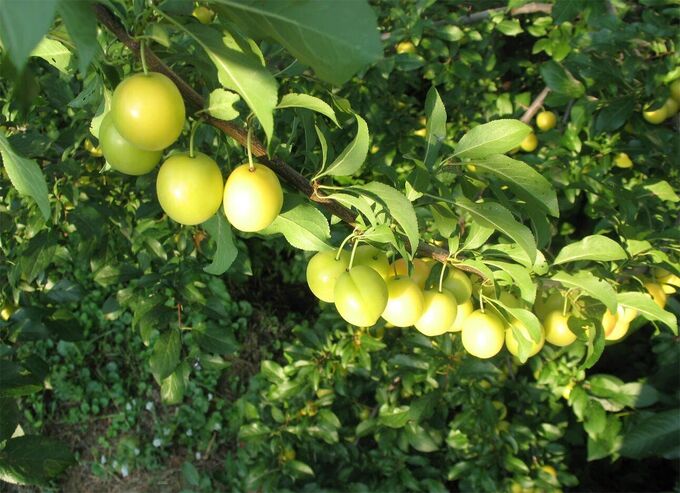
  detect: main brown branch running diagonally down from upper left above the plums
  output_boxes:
[93,4,486,278]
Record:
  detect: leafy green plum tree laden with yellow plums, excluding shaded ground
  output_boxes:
[0,0,680,491]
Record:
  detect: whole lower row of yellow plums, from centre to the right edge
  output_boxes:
[306,244,680,358]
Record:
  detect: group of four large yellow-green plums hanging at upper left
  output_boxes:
[99,72,283,232]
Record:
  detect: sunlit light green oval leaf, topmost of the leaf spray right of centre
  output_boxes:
[453,120,531,159]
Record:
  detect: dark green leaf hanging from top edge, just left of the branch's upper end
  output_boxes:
[57,0,99,74]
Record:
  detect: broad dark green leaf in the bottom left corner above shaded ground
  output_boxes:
[0,435,75,484]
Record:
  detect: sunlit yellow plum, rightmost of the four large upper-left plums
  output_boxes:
[224,163,283,232]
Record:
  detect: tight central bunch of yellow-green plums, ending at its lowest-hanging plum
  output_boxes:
[307,245,505,358]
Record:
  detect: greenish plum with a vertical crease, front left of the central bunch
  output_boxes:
[333,265,388,327]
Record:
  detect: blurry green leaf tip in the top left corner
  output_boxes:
[0,0,57,72]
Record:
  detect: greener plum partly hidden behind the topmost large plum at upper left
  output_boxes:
[99,112,163,176]
